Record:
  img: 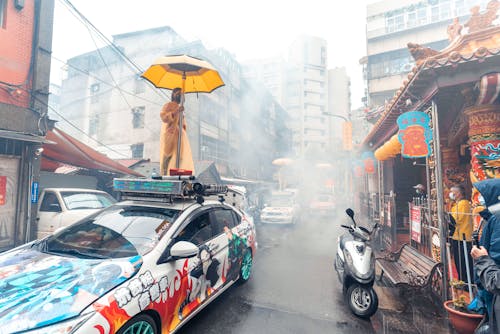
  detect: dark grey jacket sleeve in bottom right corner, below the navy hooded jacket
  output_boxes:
[474,256,500,333]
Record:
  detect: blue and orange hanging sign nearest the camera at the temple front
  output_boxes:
[397,111,432,158]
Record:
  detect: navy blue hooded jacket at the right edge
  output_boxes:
[474,179,500,265]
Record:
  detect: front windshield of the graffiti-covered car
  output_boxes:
[43,206,181,258]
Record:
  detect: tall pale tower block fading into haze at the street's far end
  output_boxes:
[243,36,351,158]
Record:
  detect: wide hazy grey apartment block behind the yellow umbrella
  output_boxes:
[58,27,286,179]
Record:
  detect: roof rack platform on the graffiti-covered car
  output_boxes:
[113,176,228,204]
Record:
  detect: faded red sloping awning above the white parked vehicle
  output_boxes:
[41,128,143,176]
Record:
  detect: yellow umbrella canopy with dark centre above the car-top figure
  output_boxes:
[142,55,224,93]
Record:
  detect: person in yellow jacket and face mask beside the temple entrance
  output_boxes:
[449,185,473,283]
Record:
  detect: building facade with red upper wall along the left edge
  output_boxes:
[0,0,54,250]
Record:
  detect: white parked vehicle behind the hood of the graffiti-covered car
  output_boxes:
[36,188,116,239]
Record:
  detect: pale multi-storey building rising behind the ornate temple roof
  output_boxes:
[363,0,488,108]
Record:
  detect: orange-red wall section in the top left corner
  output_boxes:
[0,0,35,107]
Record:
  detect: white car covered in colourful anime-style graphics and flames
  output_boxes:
[0,179,257,334]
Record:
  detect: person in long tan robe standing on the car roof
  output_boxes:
[160,87,194,175]
